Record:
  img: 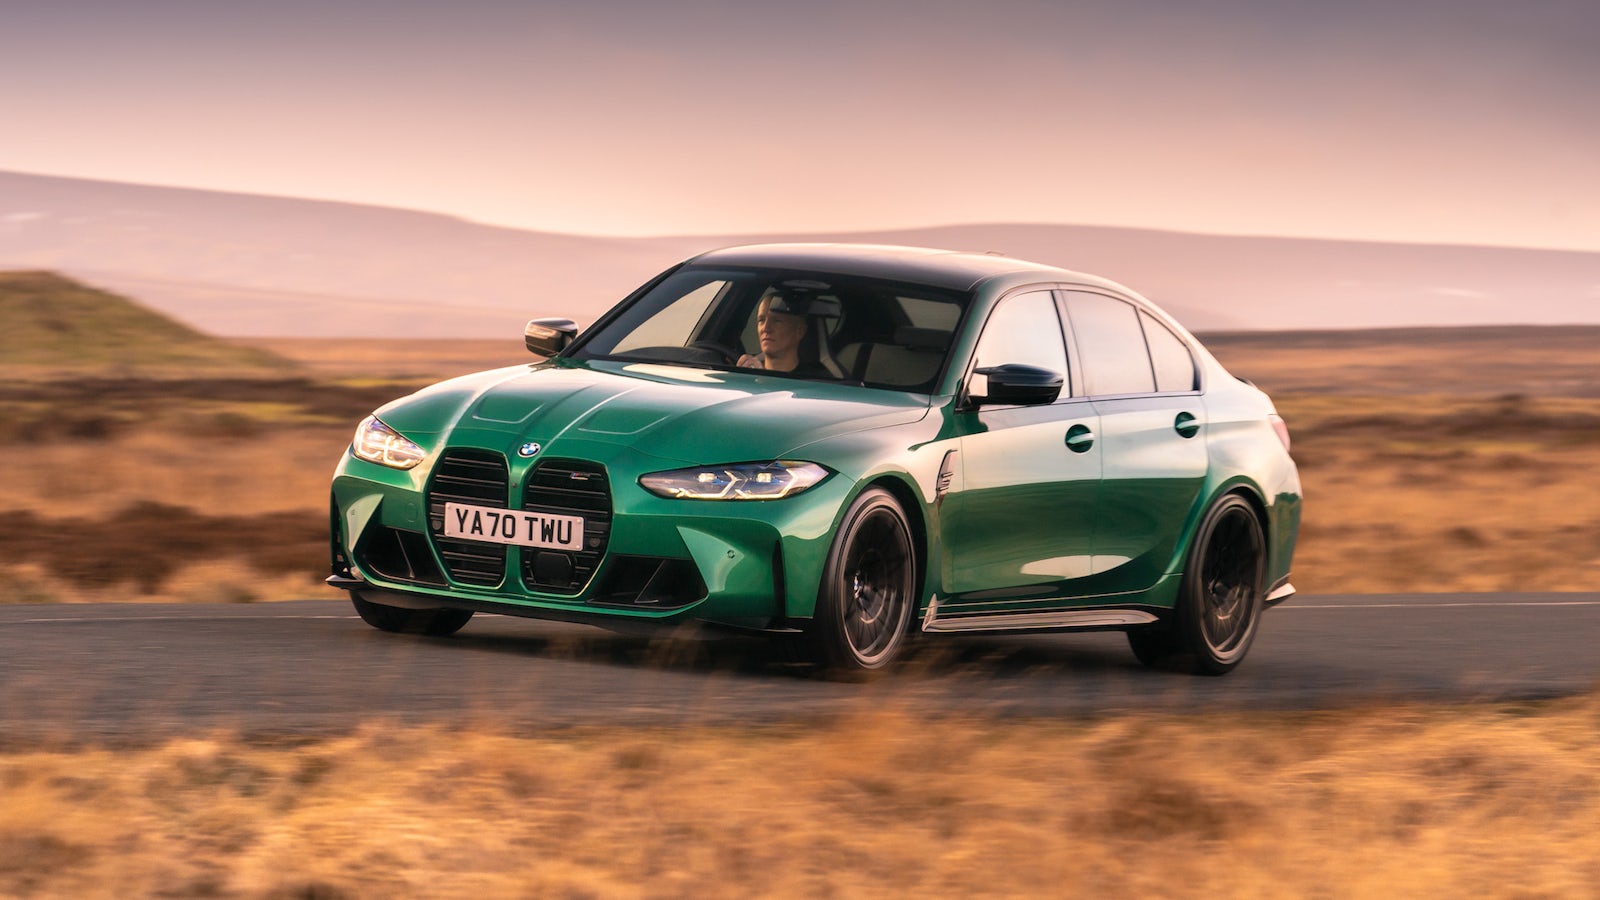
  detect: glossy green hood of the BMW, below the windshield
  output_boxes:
[378,362,930,464]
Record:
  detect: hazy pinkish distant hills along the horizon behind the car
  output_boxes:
[0,173,1600,340]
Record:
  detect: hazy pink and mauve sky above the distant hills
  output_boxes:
[0,0,1600,250]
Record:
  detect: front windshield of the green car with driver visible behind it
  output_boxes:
[571,266,968,392]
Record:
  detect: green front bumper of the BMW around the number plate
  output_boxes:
[328,447,850,631]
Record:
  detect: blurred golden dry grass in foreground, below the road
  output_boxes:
[0,697,1600,898]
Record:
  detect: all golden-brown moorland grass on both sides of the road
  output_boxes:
[0,293,1600,898]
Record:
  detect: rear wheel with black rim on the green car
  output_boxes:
[1128,493,1267,676]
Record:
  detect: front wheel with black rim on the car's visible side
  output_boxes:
[806,488,917,673]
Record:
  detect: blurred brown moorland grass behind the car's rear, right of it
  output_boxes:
[1206,327,1600,593]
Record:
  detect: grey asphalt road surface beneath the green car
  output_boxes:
[0,594,1600,745]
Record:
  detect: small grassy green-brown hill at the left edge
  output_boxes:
[0,272,294,378]
